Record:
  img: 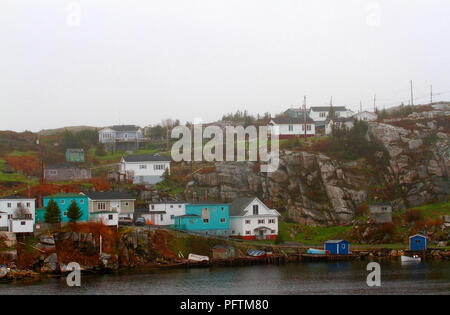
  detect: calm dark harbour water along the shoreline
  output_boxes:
[0,262,450,295]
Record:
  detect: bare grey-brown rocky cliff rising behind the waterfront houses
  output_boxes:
[185,111,450,225]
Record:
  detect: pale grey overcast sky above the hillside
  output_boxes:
[0,0,450,131]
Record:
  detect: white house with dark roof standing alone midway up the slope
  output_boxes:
[120,154,171,184]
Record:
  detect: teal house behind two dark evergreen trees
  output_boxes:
[42,193,89,223]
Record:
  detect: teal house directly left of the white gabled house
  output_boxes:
[174,202,230,236]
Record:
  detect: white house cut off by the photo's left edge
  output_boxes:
[0,196,36,233]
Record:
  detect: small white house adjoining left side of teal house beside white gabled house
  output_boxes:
[142,201,187,226]
